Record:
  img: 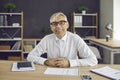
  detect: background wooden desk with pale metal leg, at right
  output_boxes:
[90,39,120,64]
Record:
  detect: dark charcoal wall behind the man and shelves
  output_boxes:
[0,0,99,38]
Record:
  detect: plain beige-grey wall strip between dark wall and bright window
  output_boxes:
[100,0,113,38]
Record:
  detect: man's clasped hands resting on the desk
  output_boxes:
[44,58,70,68]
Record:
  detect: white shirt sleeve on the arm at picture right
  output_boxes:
[69,39,98,67]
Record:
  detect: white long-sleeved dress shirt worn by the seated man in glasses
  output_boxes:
[27,31,98,67]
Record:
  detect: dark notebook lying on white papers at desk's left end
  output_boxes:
[11,61,35,71]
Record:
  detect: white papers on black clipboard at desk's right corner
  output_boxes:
[90,66,120,80]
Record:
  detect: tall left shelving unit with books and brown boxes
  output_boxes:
[0,12,23,60]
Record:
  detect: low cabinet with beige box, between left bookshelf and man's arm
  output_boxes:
[23,39,41,60]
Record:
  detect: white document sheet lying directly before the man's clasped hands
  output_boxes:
[44,68,80,76]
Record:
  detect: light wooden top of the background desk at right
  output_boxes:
[90,39,120,49]
